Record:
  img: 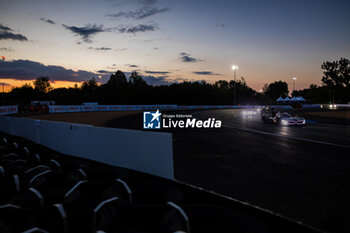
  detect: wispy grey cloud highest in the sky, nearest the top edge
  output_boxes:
[108,6,170,19]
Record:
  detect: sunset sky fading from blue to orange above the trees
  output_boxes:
[0,0,350,90]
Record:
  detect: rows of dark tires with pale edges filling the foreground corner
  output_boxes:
[0,134,320,233]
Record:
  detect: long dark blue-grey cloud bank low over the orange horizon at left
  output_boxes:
[0,60,109,82]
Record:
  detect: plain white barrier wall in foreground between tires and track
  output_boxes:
[0,117,174,179]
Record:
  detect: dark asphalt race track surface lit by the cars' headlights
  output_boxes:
[107,109,350,232]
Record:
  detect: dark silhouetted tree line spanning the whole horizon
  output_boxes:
[1,58,350,105]
